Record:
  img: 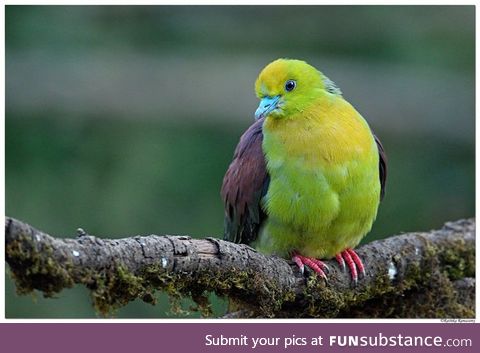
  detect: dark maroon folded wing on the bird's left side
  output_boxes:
[221,119,270,244]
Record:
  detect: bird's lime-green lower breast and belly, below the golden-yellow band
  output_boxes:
[257,132,380,258]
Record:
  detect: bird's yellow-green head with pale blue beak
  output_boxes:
[255,59,342,119]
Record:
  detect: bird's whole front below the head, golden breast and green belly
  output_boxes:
[256,97,380,258]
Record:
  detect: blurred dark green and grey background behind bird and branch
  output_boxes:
[5,6,475,318]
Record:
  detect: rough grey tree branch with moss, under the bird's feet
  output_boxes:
[5,217,475,318]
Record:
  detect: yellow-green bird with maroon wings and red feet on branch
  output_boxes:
[221,58,387,284]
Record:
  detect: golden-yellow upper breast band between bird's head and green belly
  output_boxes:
[263,98,374,166]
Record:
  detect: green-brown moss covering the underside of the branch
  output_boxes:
[6,216,475,318]
